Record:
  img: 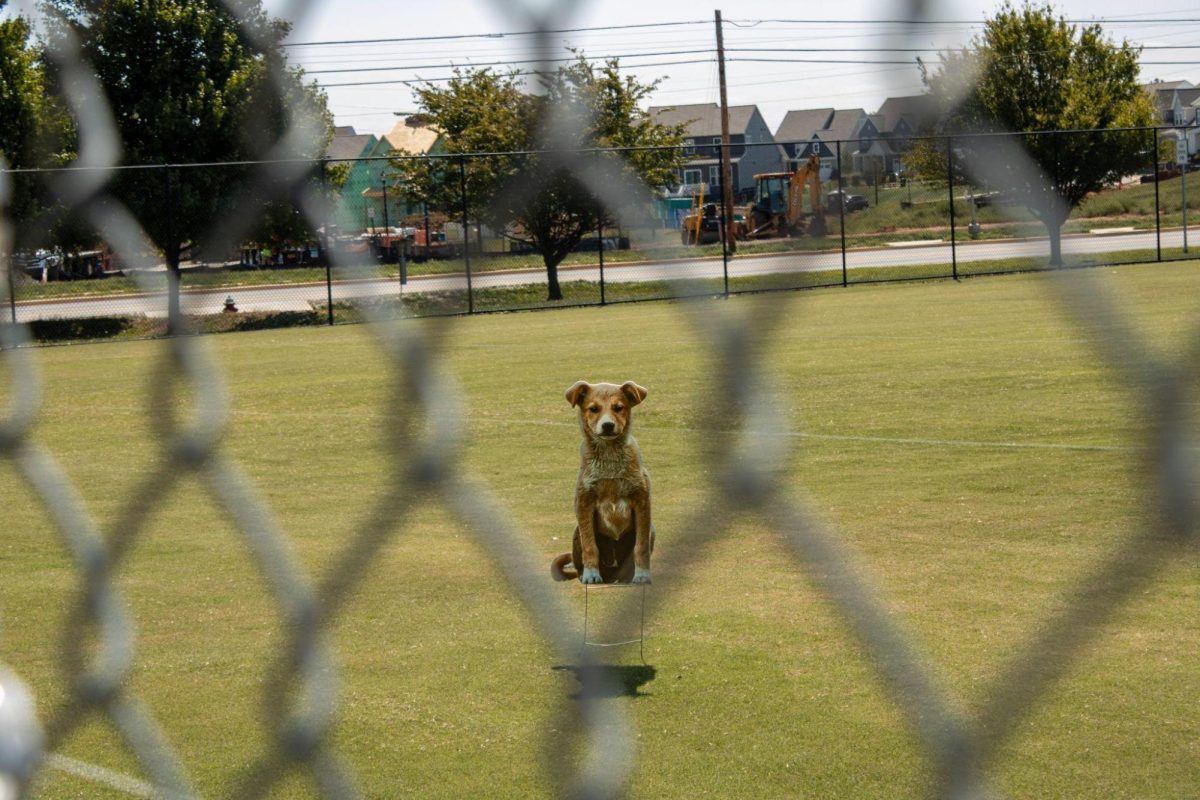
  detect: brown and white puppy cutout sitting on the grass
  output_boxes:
[550,380,654,583]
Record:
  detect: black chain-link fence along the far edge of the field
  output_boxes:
[4,128,1200,338]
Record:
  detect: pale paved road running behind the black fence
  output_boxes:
[4,225,1200,321]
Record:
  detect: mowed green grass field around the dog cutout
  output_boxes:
[0,263,1200,800]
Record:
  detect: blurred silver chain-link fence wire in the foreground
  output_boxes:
[0,2,1200,799]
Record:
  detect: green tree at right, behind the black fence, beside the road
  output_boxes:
[922,2,1154,266]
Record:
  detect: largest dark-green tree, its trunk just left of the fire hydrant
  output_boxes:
[46,0,332,325]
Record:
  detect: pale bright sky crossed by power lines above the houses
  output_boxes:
[265,0,1200,136]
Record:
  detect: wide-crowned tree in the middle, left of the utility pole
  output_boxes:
[397,54,683,300]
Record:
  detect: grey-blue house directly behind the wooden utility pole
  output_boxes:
[649,103,784,199]
